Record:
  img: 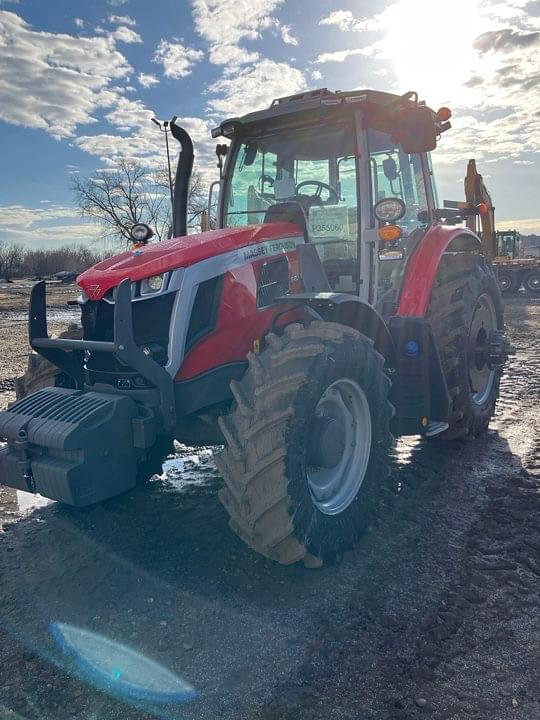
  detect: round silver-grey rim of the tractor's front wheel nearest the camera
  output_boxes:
[306,378,371,515]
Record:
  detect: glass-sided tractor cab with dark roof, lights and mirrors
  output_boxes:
[213,90,448,308]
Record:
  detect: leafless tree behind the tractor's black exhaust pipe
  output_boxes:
[73,160,209,242]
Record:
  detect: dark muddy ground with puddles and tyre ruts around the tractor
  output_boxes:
[0,286,540,720]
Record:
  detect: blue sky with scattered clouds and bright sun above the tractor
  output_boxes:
[0,0,540,247]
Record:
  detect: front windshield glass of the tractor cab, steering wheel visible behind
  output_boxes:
[223,118,358,292]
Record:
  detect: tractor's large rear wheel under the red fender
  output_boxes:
[428,254,503,439]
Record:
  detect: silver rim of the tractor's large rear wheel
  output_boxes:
[468,295,497,405]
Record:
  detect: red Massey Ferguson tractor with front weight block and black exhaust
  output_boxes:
[0,90,509,564]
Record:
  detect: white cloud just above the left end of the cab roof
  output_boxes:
[209,59,306,115]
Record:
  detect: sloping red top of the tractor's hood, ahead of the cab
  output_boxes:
[77,223,303,300]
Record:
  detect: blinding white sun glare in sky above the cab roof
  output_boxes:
[382,0,482,103]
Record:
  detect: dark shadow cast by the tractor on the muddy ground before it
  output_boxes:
[0,424,520,718]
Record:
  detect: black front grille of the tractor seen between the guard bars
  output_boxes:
[81,293,176,384]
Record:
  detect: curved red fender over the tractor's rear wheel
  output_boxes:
[396,225,478,317]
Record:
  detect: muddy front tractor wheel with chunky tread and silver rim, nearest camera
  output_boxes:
[216,322,393,565]
